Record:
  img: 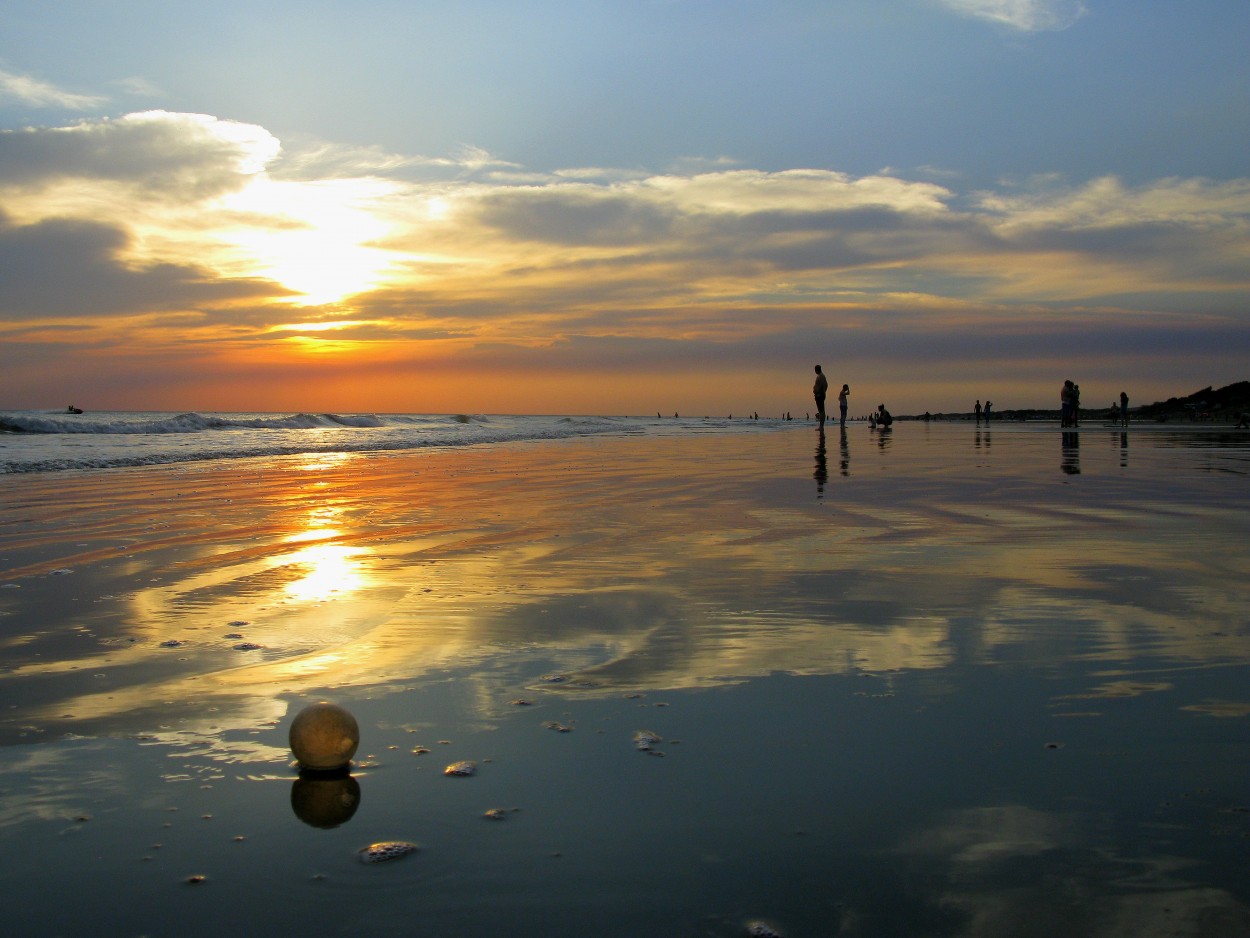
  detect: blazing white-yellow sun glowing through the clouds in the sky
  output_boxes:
[221,175,395,305]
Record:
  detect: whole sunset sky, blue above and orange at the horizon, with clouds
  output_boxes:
[0,0,1250,416]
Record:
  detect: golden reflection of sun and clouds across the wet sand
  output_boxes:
[0,433,1250,740]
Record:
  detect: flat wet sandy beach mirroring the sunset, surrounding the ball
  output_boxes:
[0,421,1250,937]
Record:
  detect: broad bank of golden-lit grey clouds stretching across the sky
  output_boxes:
[0,111,1250,409]
